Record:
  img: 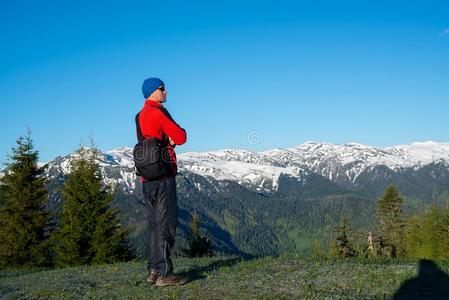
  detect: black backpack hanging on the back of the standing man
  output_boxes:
[133,113,173,181]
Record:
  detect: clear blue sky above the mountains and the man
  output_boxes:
[0,0,449,162]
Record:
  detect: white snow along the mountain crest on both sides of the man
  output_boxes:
[39,142,449,193]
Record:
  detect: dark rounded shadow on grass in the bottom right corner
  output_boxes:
[393,259,449,300]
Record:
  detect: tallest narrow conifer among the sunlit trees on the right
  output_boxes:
[378,186,405,257]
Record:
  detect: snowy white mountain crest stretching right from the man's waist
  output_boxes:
[179,142,449,189]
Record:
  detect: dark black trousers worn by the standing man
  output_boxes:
[142,176,177,276]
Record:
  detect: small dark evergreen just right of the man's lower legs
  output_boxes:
[184,211,213,257]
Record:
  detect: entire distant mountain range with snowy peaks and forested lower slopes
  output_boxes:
[6,142,449,255]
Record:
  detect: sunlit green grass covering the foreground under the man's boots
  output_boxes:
[0,256,449,299]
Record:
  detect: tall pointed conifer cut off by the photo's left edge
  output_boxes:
[0,129,50,267]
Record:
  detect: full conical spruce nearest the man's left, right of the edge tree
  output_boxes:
[53,147,131,265]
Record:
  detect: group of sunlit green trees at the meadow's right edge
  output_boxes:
[326,185,449,260]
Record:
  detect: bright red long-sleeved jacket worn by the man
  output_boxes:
[139,100,187,181]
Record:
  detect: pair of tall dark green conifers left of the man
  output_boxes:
[0,130,133,268]
